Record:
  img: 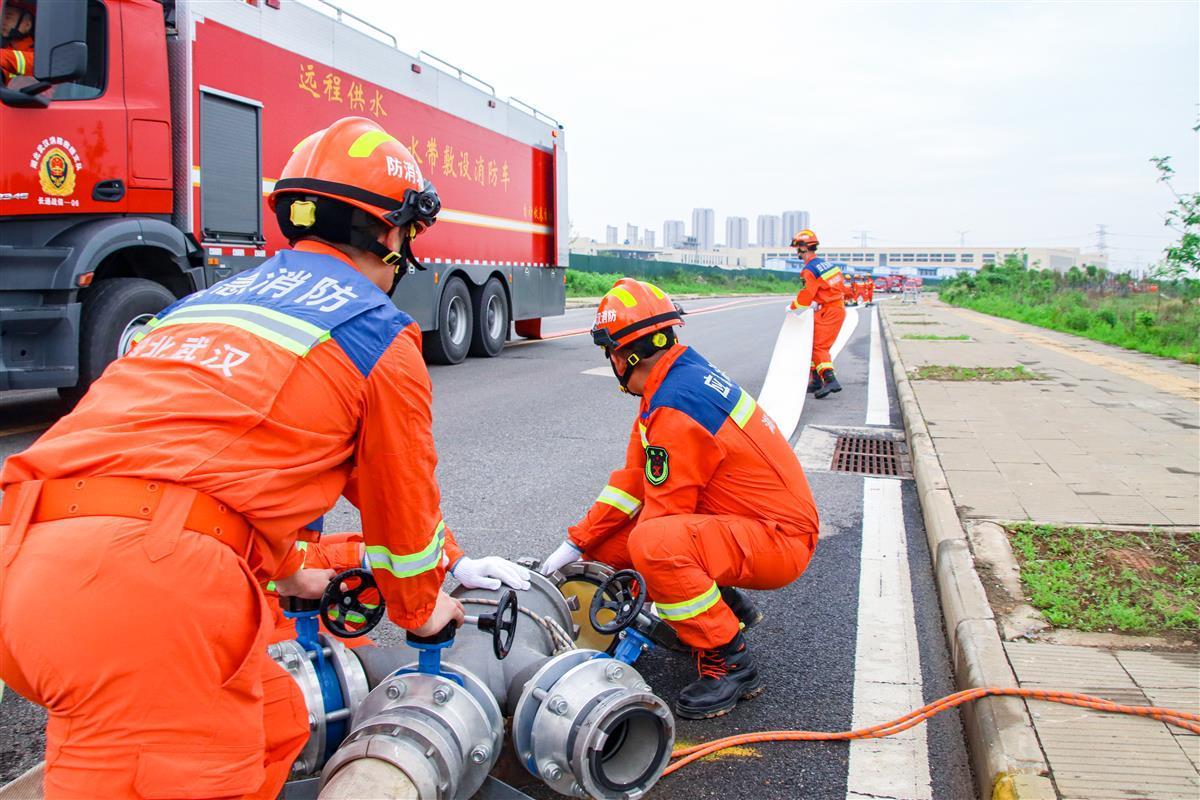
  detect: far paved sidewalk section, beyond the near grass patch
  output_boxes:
[884,300,1200,527]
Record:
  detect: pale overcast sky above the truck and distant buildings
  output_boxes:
[340,0,1200,266]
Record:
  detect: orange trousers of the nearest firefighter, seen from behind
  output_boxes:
[0,517,308,800]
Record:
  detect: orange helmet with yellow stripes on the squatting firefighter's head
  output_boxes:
[592,278,683,391]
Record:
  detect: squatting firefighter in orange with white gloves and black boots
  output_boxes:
[541,278,817,720]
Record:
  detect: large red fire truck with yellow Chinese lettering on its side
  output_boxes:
[0,0,568,396]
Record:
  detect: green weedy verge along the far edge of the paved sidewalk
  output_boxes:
[940,259,1200,363]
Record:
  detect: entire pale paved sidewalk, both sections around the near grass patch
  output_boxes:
[881,297,1200,800]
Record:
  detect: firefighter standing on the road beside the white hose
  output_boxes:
[791,228,846,398]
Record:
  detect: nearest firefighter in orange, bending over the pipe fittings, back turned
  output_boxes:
[0,118,525,798]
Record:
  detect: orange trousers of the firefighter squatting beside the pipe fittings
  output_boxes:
[583,513,816,649]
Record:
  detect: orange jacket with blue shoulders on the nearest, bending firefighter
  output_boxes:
[0,242,461,628]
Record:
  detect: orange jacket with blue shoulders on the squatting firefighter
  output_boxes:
[568,344,818,551]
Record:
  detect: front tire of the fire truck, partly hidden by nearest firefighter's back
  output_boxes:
[59,278,175,403]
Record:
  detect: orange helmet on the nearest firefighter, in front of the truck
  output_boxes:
[266,116,442,283]
